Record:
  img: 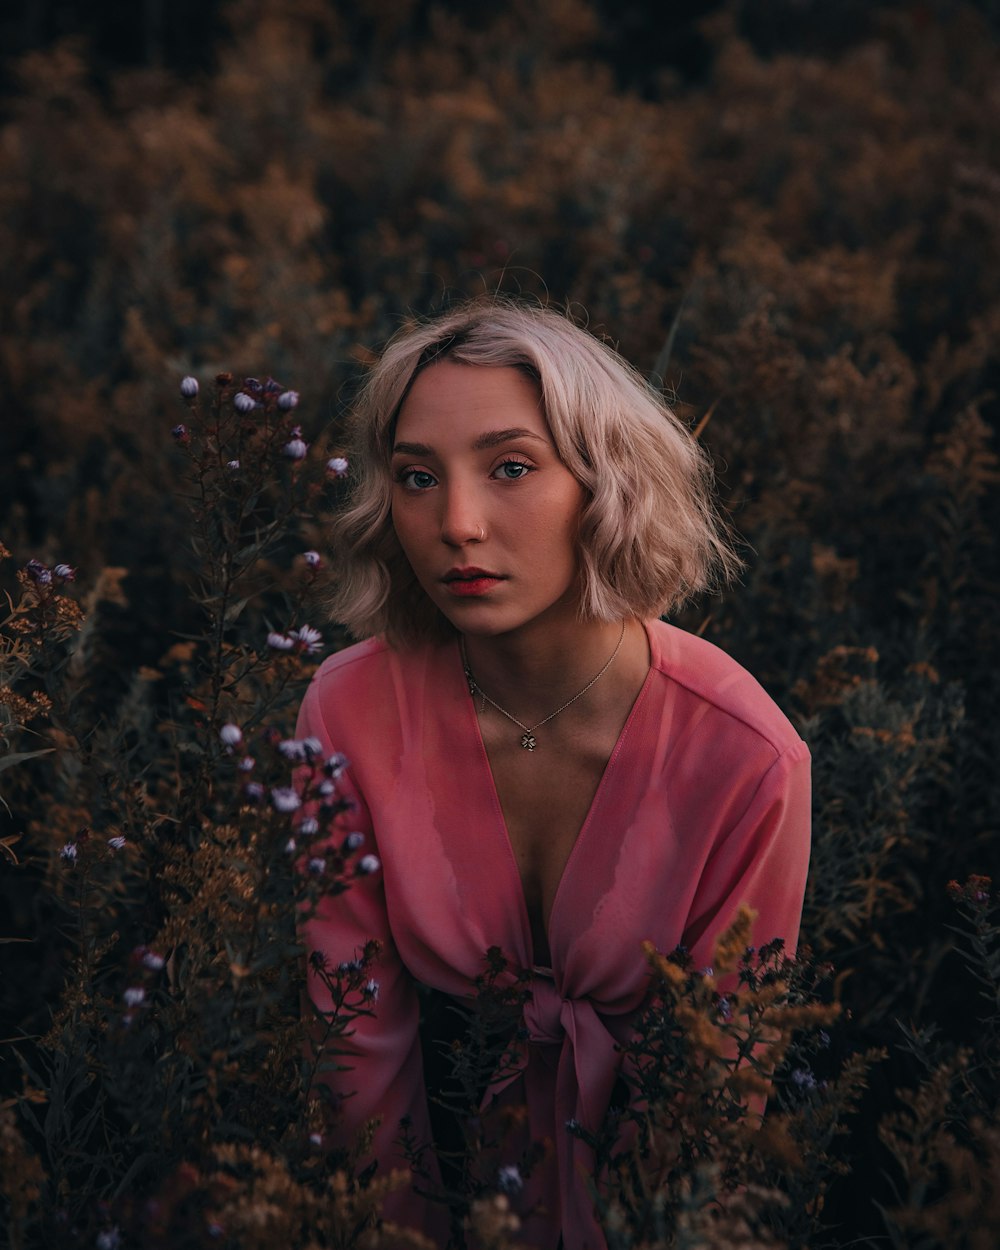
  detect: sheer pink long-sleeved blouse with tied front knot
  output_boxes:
[296,621,810,1250]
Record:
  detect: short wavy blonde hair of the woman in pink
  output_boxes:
[331,296,740,646]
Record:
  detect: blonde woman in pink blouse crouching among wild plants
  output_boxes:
[298,300,810,1250]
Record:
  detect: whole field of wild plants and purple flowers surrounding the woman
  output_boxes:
[0,0,1000,1250]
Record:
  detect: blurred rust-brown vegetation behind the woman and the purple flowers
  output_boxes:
[0,0,1000,1245]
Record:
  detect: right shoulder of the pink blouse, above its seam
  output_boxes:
[649,620,808,755]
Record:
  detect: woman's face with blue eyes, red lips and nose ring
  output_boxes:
[391,360,585,635]
